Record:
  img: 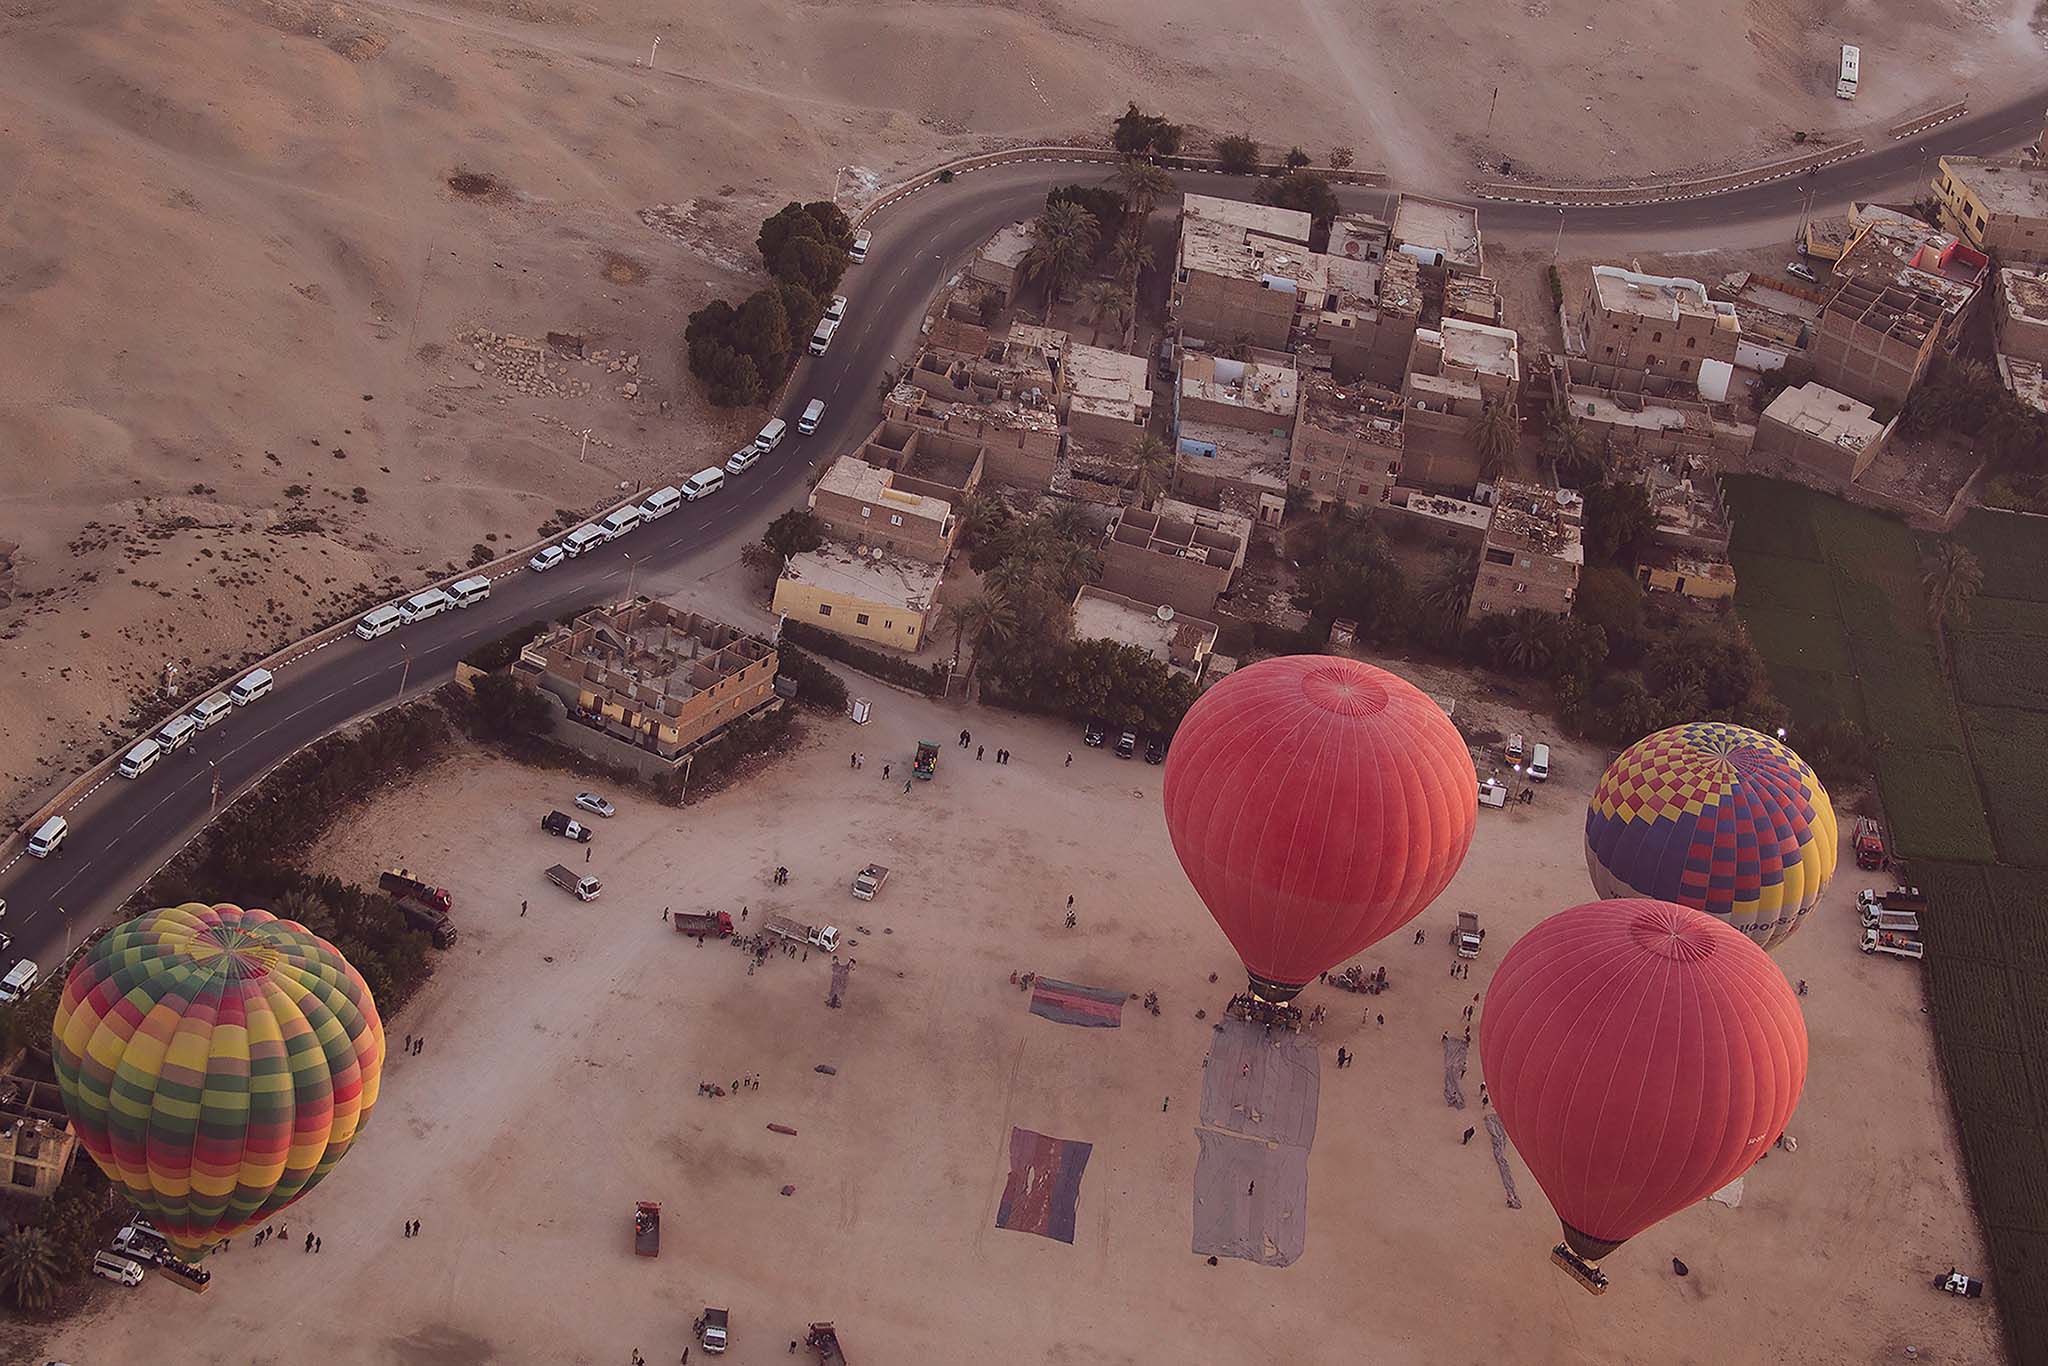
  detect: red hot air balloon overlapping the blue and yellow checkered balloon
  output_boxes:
[1479,899,1806,1290]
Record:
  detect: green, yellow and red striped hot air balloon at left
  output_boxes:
[51,901,385,1260]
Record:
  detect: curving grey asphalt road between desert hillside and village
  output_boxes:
[0,96,2044,967]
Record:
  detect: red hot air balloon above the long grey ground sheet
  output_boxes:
[1165,655,1479,1001]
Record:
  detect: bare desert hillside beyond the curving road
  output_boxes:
[0,0,2040,815]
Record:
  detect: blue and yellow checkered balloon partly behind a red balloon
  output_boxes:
[1585,721,1839,948]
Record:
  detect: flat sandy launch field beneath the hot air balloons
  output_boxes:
[19,672,1999,1366]
